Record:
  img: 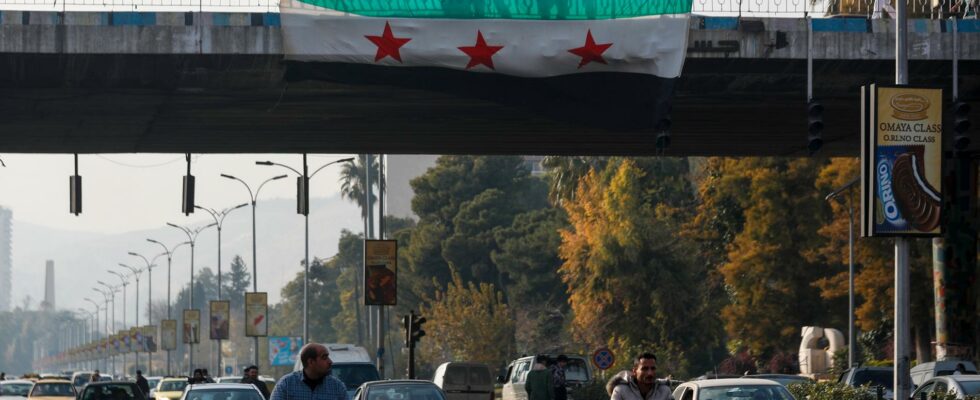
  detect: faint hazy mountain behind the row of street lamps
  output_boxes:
[11,196,363,315]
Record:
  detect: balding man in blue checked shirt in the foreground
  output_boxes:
[270,343,347,400]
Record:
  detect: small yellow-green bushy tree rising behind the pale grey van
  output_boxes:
[419,272,514,367]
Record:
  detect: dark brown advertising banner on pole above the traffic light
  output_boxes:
[364,240,398,306]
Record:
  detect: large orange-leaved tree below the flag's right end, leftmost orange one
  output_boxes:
[559,158,721,376]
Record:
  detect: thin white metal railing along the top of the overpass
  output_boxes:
[0,0,980,18]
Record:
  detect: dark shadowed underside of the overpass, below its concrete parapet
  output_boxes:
[0,14,980,156]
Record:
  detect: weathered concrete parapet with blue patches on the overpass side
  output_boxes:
[0,11,980,60]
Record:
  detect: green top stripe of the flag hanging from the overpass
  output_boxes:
[299,0,693,20]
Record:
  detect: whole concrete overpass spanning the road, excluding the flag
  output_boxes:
[0,9,980,156]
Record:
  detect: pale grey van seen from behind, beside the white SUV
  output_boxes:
[432,362,494,400]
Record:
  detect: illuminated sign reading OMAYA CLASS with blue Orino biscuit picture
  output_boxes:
[861,85,943,237]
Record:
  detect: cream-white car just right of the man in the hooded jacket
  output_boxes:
[673,378,795,400]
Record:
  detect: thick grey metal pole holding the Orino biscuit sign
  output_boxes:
[893,0,911,399]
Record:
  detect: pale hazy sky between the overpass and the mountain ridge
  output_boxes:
[0,154,360,233]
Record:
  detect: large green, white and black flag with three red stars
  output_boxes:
[280,0,692,126]
